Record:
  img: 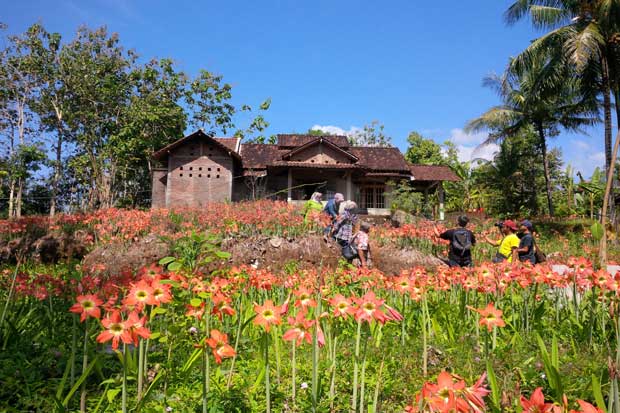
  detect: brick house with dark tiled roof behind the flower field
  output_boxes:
[152,130,458,214]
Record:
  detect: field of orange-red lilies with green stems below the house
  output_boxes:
[0,202,620,413]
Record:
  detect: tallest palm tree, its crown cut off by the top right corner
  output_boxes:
[505,0,620,216]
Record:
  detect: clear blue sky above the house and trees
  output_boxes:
[0,0,604,176]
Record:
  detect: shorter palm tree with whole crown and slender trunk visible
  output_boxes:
[465,54,597,215]
